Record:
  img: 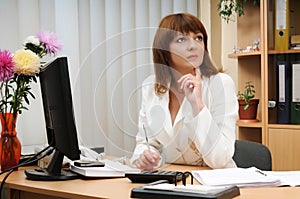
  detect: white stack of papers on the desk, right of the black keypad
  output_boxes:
[192,167,281,187]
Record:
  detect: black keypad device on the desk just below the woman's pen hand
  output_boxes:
[125,170,182,183]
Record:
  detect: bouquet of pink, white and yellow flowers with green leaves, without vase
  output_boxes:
[0,31,62,127]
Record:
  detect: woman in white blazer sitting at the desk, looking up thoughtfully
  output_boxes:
[131,13,238,170]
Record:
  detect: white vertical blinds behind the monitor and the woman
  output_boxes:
[0,0,200,156]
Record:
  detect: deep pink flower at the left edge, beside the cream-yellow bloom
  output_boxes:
[0,50,15,81]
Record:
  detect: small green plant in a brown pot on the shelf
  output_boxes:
[237,81,259,122]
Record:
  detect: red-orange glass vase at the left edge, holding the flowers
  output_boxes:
[0,113,21,171]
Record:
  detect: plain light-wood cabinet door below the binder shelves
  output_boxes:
[269,129,300,171]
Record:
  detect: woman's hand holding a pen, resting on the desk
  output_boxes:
[134,150,161,170]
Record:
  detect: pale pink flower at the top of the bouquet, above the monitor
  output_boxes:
[37,30,62,55]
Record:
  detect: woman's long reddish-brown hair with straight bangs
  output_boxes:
[152,13,218,95]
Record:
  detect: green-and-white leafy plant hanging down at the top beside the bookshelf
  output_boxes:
[217,0,260,23]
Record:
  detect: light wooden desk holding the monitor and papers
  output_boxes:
[1,165,300,199]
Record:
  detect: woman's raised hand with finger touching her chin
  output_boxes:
[178,68,204,115]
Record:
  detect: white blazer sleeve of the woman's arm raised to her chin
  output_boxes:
[186,73,238,168]
